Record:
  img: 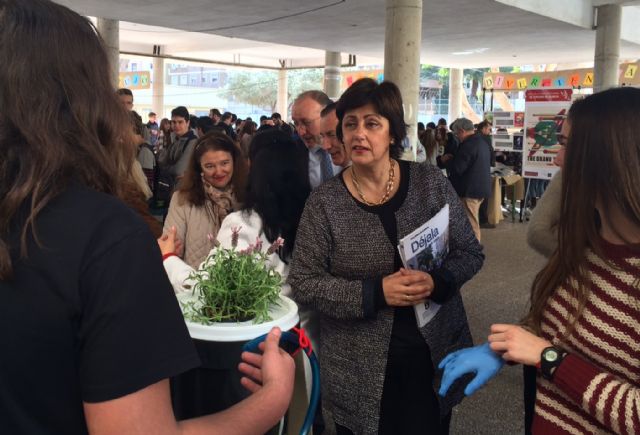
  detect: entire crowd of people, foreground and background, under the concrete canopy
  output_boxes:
[0,0,640,434]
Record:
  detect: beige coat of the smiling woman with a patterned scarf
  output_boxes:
[164,192,221,269]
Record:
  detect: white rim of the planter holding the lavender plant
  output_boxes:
[176,292,300,342]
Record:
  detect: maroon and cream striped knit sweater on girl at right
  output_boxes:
[532,242,640,434]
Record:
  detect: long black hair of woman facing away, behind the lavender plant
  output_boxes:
[244,129,311,263]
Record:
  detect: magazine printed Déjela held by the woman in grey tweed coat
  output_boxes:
[398,204,449,328]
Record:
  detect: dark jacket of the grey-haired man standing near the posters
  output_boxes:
[446,134,491,199]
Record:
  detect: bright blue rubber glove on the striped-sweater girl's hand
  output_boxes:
[438,343,504,397]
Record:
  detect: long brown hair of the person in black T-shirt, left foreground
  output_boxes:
[0,0,135,280]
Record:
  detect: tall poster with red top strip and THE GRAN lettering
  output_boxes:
[522,88,573,180]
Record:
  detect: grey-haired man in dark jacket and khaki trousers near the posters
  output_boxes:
[442,118,491,241]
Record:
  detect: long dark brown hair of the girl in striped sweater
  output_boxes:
[524,88,640,335]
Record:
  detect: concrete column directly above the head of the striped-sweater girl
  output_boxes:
[593,4,622,92]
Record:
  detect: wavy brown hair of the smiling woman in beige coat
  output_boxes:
[178,131,249,206]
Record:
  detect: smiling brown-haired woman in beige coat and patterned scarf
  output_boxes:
[164,132,247,268]
